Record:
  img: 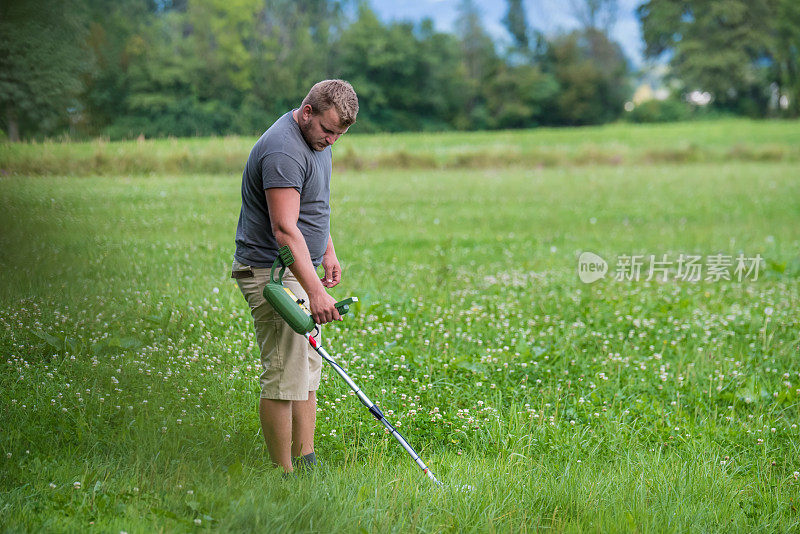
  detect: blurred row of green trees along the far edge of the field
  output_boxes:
[0,0,800,140]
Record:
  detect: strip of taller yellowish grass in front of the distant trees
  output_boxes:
[0,119,800,176]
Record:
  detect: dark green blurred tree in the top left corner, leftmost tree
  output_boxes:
[0,0,89,141]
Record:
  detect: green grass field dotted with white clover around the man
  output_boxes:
[0,122,800,533]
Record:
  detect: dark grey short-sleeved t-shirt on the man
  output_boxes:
[234,112,332,267]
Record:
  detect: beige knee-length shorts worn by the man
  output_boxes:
[233,260,322,401]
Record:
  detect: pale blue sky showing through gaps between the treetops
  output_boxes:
[370,0,644,67]
